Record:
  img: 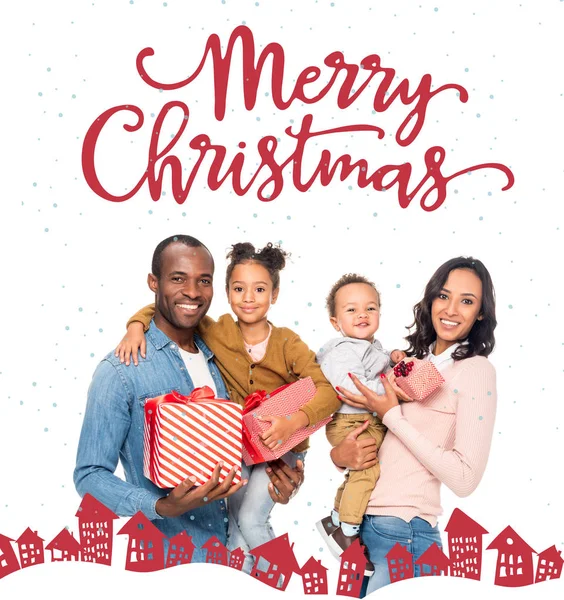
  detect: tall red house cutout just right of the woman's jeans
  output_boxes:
[445,508,488,580]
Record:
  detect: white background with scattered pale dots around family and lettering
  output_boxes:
[0,0,564,598]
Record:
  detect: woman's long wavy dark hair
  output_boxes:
[405,256,497,360]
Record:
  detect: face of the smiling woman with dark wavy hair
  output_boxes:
[431,269,482,354]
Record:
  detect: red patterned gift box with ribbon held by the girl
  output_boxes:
[243,377,331,465]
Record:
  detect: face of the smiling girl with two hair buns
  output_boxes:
[227,263,279,324]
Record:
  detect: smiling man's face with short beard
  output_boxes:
[148,243,214,337]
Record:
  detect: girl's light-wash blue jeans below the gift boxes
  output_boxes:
[227,452,306,574]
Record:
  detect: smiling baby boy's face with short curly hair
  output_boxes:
[330,283,380,342]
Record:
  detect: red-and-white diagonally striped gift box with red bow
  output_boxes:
[143,386,241,488]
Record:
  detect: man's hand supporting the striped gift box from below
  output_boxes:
[155,463,247,517]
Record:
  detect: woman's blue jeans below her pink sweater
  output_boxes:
[360,515,443,595]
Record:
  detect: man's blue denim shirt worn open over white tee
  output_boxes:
[74,321,228,562]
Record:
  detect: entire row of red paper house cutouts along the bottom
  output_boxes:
[0,494,564,598]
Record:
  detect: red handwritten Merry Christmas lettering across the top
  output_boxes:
[82,26,514,211]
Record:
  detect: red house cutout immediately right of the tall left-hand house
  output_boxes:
[118,511,166,573]
